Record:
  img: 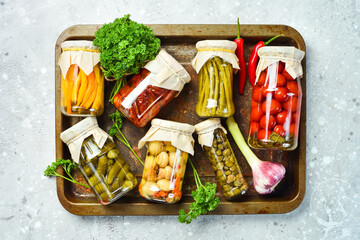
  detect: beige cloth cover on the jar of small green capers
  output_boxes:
[195,118,227,147]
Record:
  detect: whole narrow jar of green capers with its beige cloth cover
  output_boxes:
[195,118,249,199]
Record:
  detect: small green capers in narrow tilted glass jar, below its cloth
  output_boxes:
[204,128,249,199]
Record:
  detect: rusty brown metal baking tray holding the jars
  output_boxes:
[55,25,306,215]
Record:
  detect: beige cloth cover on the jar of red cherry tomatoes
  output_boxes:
[255,46,305,83]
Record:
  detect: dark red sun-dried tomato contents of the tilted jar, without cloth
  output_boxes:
[114,68,178,127]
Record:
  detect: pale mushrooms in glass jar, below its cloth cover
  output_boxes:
[139,141,188,203]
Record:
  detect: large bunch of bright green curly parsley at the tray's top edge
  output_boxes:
[93,14,160,79]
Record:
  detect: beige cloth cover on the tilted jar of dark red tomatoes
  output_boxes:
[144,49,191,92]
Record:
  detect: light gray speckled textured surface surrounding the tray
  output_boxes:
[0,0,360,239]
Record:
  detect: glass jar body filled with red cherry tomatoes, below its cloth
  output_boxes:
[248,61,302,150]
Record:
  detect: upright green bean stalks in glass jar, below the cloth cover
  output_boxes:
[196,56,235,117]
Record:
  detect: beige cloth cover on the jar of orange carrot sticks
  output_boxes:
[58,41,100,77]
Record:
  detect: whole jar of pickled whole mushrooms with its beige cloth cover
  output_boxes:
[139,119,194,203]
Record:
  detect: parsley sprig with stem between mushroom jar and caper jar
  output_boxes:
[178,158,220,224]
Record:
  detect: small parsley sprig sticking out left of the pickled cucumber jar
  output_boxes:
[44,158,90,188]
